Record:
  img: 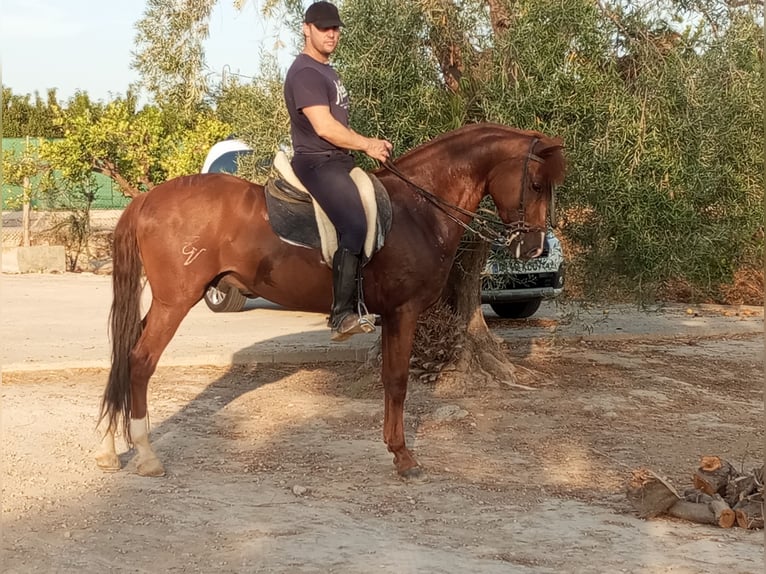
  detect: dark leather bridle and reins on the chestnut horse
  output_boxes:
[383,138,555,246]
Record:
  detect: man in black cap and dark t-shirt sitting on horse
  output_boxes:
[284,2,392,341]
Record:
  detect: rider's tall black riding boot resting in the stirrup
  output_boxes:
[330,248,375,341]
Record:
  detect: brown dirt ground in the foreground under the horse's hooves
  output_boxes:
[2,335,764,574]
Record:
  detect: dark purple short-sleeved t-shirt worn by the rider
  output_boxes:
[284,54,348,153]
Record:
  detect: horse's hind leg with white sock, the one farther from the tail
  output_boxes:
[129,299,191,476]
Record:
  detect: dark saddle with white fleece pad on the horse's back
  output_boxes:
[264,150,391,268]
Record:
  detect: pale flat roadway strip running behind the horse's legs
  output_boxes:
[0,273,763,372]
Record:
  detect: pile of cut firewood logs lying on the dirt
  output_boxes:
[627,456,764,529]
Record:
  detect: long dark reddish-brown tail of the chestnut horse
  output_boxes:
[99,195,145,438]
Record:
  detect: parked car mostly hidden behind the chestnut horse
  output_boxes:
[202,138,564,319]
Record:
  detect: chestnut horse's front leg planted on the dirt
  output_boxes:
[381,313,420,478]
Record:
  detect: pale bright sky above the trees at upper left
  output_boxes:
[0,0,293,101]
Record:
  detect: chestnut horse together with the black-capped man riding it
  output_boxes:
[96,7,566,477]
